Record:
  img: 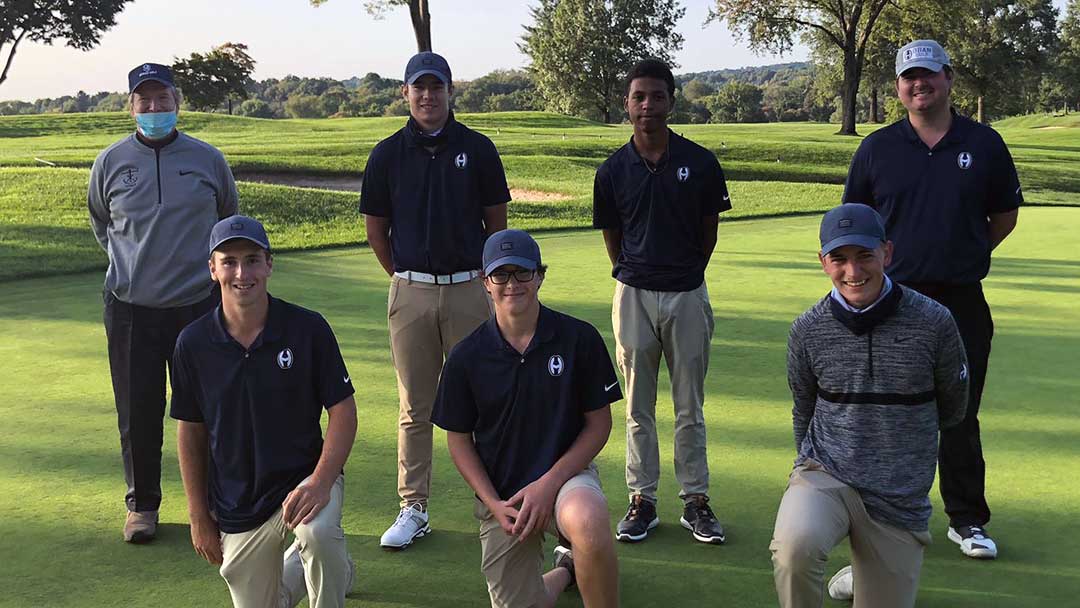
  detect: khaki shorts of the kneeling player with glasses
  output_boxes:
[473,463,604,608]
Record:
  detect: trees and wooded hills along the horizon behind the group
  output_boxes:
[0,0,1080,127]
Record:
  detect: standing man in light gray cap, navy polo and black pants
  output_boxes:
[843,40,1024,558]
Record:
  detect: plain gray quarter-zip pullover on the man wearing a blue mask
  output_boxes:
[86,133,238,308]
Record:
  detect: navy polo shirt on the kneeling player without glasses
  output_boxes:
[170,297,353,533]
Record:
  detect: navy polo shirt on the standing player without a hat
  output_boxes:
[593,132,731,292]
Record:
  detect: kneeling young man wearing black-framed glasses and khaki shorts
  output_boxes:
[431,230,622,608]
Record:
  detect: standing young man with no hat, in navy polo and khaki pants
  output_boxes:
[593,59,731,543]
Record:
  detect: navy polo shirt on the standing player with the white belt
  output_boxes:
[360,114,510,274]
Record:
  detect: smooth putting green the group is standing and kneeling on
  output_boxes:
[0,208,1080,608]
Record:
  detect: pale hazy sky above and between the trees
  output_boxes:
[0,0,1066,99]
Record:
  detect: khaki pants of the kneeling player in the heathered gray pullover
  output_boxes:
[769,461,930,608]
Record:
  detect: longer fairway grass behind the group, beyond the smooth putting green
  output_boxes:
[0,112,1080,281]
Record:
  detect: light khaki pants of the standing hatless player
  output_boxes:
[611,282,713,502]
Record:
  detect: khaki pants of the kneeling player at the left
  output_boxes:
[220,475,353,608]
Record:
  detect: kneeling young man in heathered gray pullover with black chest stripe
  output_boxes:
[769,204,968,608]
